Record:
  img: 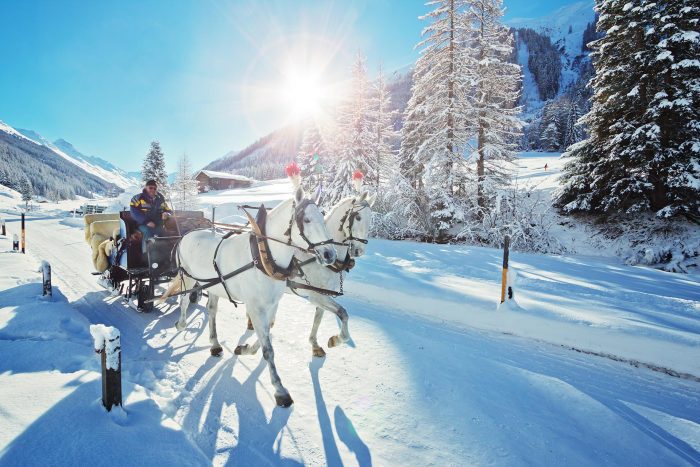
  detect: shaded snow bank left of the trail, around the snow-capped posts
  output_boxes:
[0,234,209,466]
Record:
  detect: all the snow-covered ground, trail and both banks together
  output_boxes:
[0,158,700,466]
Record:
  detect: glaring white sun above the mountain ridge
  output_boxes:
[282,70,326,117]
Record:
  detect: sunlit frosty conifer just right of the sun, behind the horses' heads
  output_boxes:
[324,52,376,205]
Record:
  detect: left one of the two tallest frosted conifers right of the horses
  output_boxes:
[396,0,472,240]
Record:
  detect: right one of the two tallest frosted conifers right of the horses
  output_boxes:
[466,0,523,211]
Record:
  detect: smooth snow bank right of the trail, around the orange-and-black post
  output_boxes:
[348,239,700,377]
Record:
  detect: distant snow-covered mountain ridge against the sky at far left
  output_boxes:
[16,128,137,189]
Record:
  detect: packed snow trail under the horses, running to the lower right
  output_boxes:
[0,213,700,465]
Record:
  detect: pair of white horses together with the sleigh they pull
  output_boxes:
[86,164,376,407]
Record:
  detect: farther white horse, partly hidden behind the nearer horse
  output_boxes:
[236,191,377,357]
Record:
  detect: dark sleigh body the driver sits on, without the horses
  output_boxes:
[93,211,211,312]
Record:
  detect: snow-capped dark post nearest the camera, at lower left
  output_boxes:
[90,324,122,411]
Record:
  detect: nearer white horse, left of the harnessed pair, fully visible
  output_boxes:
[161,181,336,407]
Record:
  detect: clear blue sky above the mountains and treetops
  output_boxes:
[0,0,572,170]
